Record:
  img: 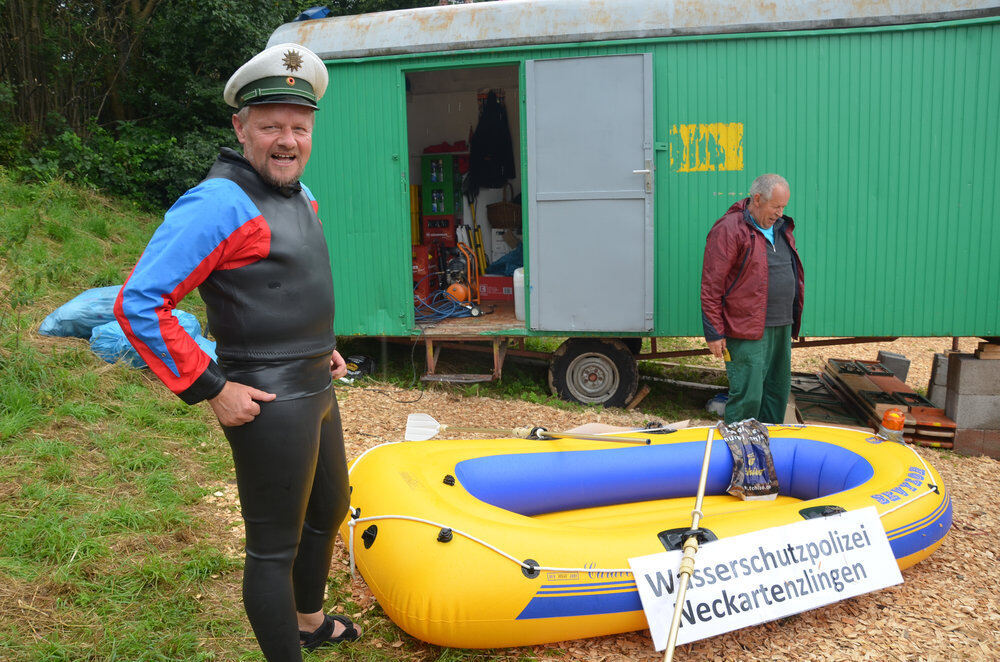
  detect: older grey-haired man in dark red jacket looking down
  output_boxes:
[701,174,805,424]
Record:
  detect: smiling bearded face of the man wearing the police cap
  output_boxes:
[233,103,315,186]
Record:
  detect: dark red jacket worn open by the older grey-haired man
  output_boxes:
[701,198,805,341]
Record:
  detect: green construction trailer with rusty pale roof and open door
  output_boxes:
[269,0,1000,405]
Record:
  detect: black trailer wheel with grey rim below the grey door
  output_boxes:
[549,338,639,407]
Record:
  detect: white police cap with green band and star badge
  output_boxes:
[222,44,330,108]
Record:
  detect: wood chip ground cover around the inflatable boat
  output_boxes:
[210,338,1000,662]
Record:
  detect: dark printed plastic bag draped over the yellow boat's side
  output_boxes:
[717,418,778,501]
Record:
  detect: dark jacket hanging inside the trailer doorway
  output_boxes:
[462,90,515,200]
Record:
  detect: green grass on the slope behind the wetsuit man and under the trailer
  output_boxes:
[0,169,703,662]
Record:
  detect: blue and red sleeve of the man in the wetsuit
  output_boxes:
[115,178,271,404]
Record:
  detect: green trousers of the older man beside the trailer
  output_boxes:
[725,325,792,425]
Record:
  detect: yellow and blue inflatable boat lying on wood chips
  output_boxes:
[342,426,951,648]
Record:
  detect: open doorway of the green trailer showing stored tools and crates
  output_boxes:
[405,64,525,335]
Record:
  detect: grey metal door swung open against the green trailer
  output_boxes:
[525,54,653,331]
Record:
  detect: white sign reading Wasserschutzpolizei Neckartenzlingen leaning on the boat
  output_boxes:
[629,506,903,651]
